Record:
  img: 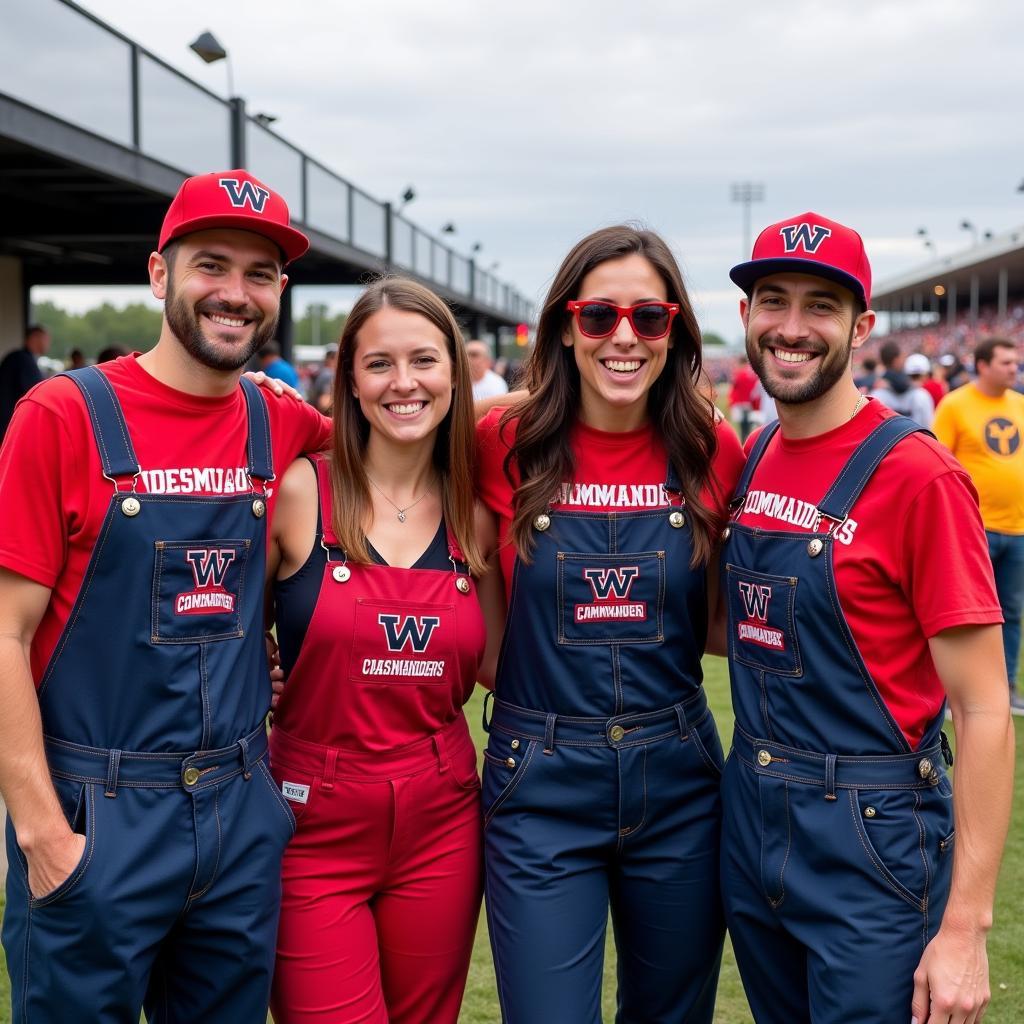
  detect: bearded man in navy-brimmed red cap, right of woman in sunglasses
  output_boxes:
[721,213,1014,1024]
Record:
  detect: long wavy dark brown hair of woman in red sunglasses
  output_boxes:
[501,224,719,566]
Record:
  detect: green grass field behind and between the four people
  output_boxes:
[0,657,1024,1024]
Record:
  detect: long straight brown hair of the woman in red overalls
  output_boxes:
[331,278,485,574]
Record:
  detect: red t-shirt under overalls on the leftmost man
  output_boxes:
[0,352,330,683]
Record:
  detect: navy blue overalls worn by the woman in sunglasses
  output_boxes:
[483,473,724,1024]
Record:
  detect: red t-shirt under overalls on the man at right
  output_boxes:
[736,400,1002,748]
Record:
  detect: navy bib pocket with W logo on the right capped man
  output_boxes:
[725,563,804,676]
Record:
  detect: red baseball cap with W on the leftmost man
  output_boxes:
[159,170,309,263]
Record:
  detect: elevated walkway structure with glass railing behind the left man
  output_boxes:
[0,0,534,351]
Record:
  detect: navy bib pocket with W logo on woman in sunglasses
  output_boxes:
[557,551,665,644]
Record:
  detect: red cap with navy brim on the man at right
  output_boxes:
[729,213,871,306]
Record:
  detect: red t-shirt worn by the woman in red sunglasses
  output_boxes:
[476,409,743,591]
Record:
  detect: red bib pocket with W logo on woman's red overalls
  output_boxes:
[348,600,458,686]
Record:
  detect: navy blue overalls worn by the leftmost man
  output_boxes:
[3,368,295,1024]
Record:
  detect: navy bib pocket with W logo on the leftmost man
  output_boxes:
[152,539,252,643]
